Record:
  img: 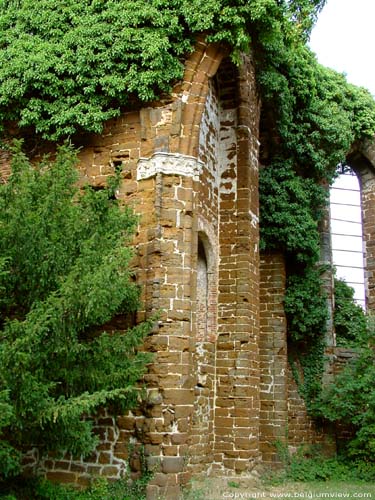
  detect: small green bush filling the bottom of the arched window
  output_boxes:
[334,279,367,347]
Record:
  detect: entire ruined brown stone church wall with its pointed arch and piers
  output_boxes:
[4,36,375,498]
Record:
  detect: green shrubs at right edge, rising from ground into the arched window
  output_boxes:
[310,279,375,460]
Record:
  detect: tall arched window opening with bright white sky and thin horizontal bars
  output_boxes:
[330,166,366,309]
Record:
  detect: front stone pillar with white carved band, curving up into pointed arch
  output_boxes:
[137,41,229,498]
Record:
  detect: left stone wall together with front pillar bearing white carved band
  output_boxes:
[14,42,231,498]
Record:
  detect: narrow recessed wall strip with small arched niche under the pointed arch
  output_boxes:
[188,78,220,474]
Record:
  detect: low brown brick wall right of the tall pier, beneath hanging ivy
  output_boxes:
[259,253,334,464]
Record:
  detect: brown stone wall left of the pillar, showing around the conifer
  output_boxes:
[26,108,163,485]
